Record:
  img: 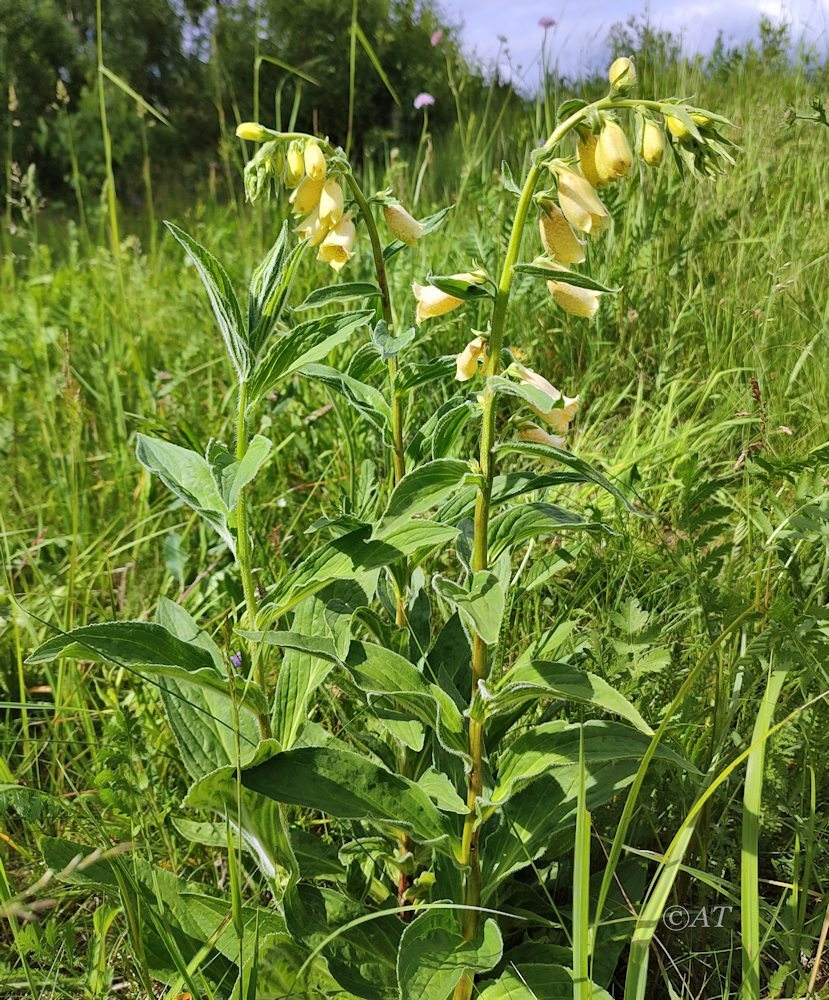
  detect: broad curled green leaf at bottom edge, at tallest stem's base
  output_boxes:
[397,909,503,1000]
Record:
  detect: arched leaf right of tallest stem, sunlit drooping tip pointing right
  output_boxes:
[487,660,653,735]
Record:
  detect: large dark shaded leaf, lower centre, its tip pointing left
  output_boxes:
[242,746,454,856]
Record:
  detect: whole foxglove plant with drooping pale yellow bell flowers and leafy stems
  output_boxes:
[31,60,733,1000]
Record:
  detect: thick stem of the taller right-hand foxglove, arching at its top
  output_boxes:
[454,98,612,1000]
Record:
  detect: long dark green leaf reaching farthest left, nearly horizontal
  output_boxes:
[26,621,267,714]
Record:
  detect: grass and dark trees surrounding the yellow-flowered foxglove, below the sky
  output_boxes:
[0,0,829,997]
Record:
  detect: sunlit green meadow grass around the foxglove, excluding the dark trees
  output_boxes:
[0,27,829,998]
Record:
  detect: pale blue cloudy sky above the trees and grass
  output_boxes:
[439,0,829,86]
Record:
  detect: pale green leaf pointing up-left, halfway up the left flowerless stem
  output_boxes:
[135,434,236,552]
